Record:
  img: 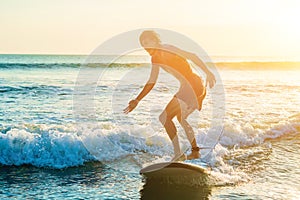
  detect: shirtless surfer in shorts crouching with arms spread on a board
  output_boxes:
[124,30,216,161]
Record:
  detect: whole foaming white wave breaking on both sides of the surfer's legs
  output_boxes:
[0,116,300,168]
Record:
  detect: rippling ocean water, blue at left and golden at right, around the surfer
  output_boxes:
[0,55,300,199]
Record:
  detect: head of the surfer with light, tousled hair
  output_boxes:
[140,30,161,50]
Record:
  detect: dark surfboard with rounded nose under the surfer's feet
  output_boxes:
[140,162,209,178]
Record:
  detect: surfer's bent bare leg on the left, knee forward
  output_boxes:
[159,97,182,159]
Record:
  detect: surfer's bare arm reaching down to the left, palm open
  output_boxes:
[124,65,159,114]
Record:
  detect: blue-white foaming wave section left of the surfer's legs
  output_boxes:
[0,125,171,169]
